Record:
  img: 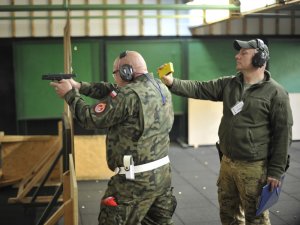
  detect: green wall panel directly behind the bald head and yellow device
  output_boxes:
[106,40,185,114]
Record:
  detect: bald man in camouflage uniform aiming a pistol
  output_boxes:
[51,51,176,225]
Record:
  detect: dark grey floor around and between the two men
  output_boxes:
[78,142,300,225]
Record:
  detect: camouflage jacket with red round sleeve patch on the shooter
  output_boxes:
[65,74,174,193]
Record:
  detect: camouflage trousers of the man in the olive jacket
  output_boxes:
[217,156,271,225]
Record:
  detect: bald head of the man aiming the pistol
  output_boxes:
[114,51,148,77]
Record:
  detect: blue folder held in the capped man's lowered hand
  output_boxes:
[256,175,284,216]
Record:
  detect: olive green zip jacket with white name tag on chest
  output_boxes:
[170,71,293,179]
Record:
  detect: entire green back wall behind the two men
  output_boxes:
[14,38,300,120]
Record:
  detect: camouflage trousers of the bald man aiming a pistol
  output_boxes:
[98,185,177,225]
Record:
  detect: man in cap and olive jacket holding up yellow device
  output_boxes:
[162,39,293,225]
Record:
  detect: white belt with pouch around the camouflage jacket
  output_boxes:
[114,155,170,180]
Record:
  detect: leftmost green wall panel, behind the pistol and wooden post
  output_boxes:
[14,41,100,120]
